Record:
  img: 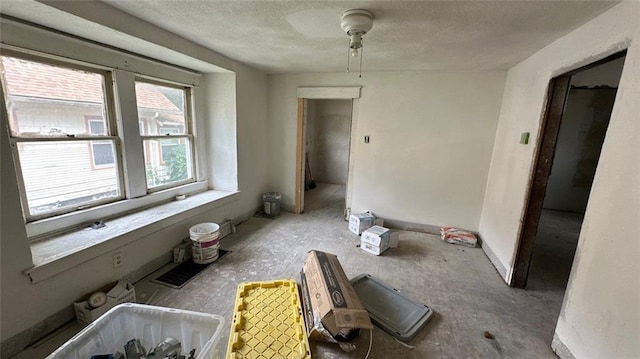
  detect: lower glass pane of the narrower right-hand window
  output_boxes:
[143,138,193,188]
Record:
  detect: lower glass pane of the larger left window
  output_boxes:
[18,141,120,215]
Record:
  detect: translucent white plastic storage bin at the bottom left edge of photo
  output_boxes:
[47,303,224,359]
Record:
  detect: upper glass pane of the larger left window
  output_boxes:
[1,56,106,137]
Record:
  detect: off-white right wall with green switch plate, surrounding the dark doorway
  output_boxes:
[480,2,640,358]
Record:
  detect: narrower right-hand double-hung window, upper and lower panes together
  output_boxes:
[136,81,194,191]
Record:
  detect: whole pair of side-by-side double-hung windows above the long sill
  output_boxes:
[0,49,200,228]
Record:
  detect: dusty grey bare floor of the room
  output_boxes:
[16,187,576,358]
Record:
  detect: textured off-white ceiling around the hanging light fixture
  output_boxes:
[2,0,617,73]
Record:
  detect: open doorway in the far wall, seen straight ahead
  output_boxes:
[302,99,353,212]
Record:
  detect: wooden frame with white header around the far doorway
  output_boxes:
[293,86,362,214]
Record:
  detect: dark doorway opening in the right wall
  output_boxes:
[511,51,626,292]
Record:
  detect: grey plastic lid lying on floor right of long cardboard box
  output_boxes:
[350,274,433,342]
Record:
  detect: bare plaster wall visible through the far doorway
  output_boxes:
[307,100,351,184]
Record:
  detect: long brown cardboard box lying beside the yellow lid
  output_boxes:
[300,250,373,341]
